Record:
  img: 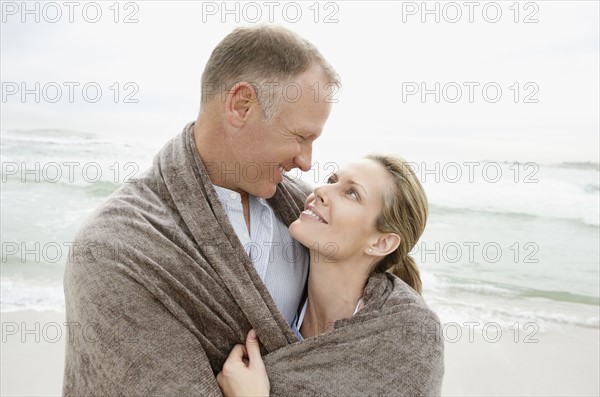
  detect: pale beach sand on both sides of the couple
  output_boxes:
[0,311,600,396]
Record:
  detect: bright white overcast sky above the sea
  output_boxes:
[1,1,600,163]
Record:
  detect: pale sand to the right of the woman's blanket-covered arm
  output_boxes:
[442,326,600,396]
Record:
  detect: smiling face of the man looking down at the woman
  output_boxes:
[232,68,331,198]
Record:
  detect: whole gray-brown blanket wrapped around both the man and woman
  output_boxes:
[63,124,443,396]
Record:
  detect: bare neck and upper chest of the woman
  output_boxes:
[300,252,367,338]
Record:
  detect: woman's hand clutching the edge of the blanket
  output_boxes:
[217,329,270,397]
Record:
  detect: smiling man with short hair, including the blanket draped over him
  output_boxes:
[63,26,339,395]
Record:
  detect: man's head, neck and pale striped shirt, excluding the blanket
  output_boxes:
[194,27,339,322]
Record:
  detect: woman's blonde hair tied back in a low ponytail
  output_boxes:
[367,155,429,294]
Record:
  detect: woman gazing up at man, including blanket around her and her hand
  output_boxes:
[217,155,443,396]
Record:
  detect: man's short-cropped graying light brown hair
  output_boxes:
[202,25,341,121]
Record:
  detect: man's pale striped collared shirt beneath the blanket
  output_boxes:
[213,185,308,323]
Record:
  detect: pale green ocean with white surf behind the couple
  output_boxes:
[0,130,600,335]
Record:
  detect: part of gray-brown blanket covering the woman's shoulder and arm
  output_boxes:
[263,273,444,396]
